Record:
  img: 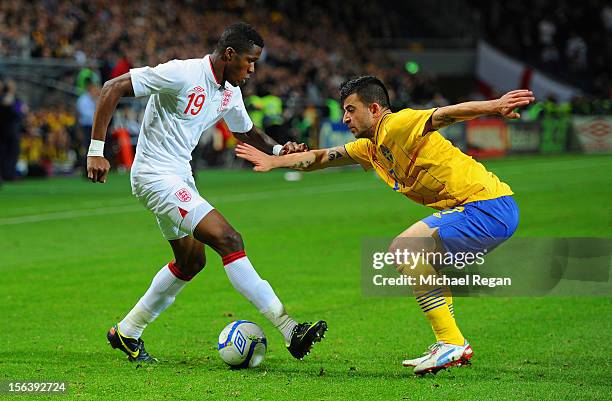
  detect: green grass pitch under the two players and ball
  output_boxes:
[0,155,612,400]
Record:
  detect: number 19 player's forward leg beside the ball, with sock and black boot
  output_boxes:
[193,210,327,359]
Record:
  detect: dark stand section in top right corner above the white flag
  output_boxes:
[472,0,612,99]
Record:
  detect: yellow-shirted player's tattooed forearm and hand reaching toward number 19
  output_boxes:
[236,144,357,172]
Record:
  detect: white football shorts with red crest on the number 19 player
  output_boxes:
[132,175,214,240]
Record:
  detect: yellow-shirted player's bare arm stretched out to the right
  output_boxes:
[426,89,535,132]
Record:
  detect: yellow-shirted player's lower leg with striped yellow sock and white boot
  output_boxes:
[390,221,472,374]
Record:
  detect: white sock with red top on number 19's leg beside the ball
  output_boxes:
[223,251,297,343]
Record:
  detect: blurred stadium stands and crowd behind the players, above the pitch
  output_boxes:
[0,1,612,180]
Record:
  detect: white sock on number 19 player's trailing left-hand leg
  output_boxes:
[119,262,191,338]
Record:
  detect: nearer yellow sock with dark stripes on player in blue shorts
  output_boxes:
[409,264,465,345]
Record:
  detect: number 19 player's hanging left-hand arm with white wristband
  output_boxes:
[87,72,134,183]
